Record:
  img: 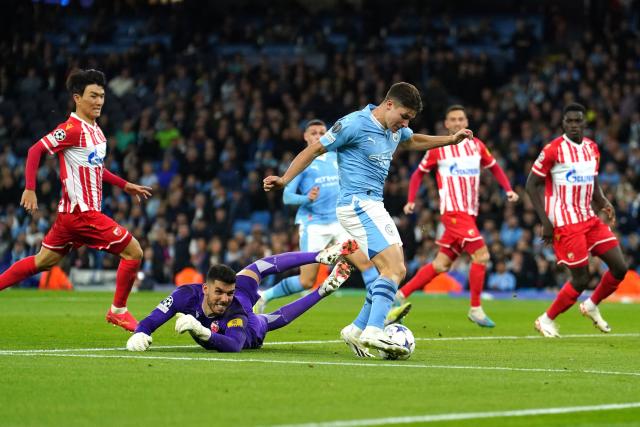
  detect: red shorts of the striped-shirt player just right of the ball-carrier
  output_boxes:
[436,212,485,259]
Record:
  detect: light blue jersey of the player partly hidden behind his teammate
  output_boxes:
[283,152,340,224]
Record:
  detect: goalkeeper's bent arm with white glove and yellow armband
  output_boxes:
[181,316,247,353]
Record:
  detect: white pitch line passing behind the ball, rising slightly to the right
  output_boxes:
[0,333,640,354]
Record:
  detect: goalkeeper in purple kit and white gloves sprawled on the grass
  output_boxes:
[127,240,358,352]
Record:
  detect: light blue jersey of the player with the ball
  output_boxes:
[320,104,413,206]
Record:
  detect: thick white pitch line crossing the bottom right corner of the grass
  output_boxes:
[264,402,640,427]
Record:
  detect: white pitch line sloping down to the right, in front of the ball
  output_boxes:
[0,352,640,377]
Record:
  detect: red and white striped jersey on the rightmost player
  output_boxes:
[531,135,600,227]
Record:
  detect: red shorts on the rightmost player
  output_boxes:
[553,217,619,268]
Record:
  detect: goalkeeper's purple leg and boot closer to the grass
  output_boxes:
[262,261,352,331]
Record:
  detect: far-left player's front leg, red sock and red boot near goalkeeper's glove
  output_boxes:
[106,237,143,331]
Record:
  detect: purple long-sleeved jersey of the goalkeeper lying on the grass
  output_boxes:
[136,276,267,352]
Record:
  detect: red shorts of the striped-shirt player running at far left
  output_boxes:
[42,211,133,255]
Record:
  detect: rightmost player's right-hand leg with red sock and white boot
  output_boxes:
[580,239,628,332]
